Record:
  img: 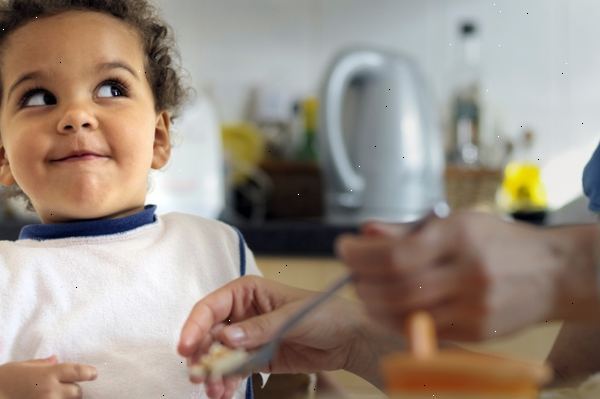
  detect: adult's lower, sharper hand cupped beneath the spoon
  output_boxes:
[178,276,363,398]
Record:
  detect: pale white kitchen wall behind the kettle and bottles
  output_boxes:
[157,0,600,209]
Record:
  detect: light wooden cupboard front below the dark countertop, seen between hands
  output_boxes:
[257,256,560,399]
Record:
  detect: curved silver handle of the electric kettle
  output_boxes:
[321,51,383,203]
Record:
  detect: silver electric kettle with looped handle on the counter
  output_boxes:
[318,49,445,225]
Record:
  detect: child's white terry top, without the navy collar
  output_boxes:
[0,211,260,399]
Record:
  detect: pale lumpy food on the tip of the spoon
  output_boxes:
[189,342,248,378]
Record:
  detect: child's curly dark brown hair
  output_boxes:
[0,0,193,211]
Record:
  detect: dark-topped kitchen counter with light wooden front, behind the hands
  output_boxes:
[0,217,560,399]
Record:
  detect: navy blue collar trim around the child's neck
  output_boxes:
[19,205,156,241]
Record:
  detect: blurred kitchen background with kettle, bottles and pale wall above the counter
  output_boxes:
[4,0,600,254]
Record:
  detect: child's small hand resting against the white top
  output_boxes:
[0,356,97,399]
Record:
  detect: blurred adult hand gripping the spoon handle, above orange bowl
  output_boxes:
[337,213,597,340]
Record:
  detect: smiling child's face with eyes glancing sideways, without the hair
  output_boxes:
[0,11,170,223]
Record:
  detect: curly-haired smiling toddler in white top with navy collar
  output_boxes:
[0,0,259,399]
